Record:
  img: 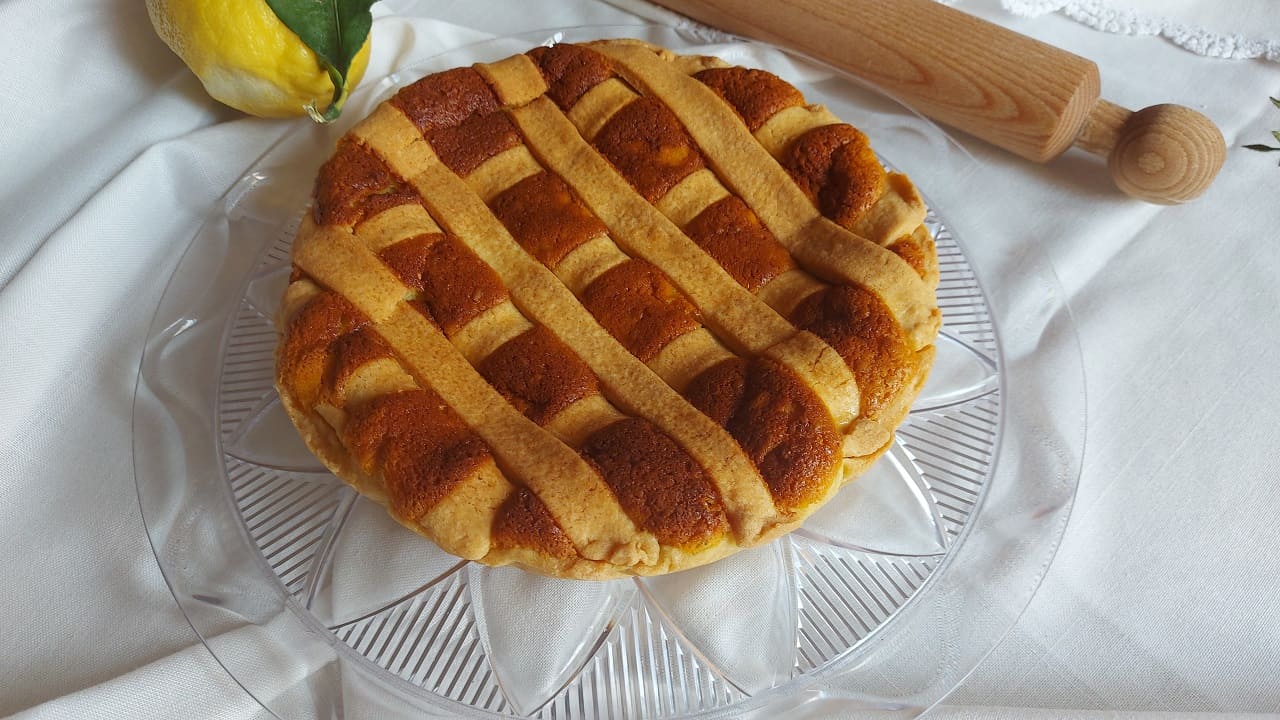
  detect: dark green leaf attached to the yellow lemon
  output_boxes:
[266,0,376,123]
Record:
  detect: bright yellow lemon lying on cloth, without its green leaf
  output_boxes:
[146,0,369,119]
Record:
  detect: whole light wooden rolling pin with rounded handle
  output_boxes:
[657,0,1226,205]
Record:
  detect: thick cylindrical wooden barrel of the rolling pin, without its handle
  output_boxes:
[659,0,1100,161]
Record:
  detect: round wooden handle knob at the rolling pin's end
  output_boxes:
[1075,100,1226,205]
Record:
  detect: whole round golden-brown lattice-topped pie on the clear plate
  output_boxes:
[276,40,941,579]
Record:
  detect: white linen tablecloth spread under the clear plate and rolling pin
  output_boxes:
[0,0,1280,720]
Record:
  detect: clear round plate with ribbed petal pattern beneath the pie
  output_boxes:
[133,26,1084,719]
